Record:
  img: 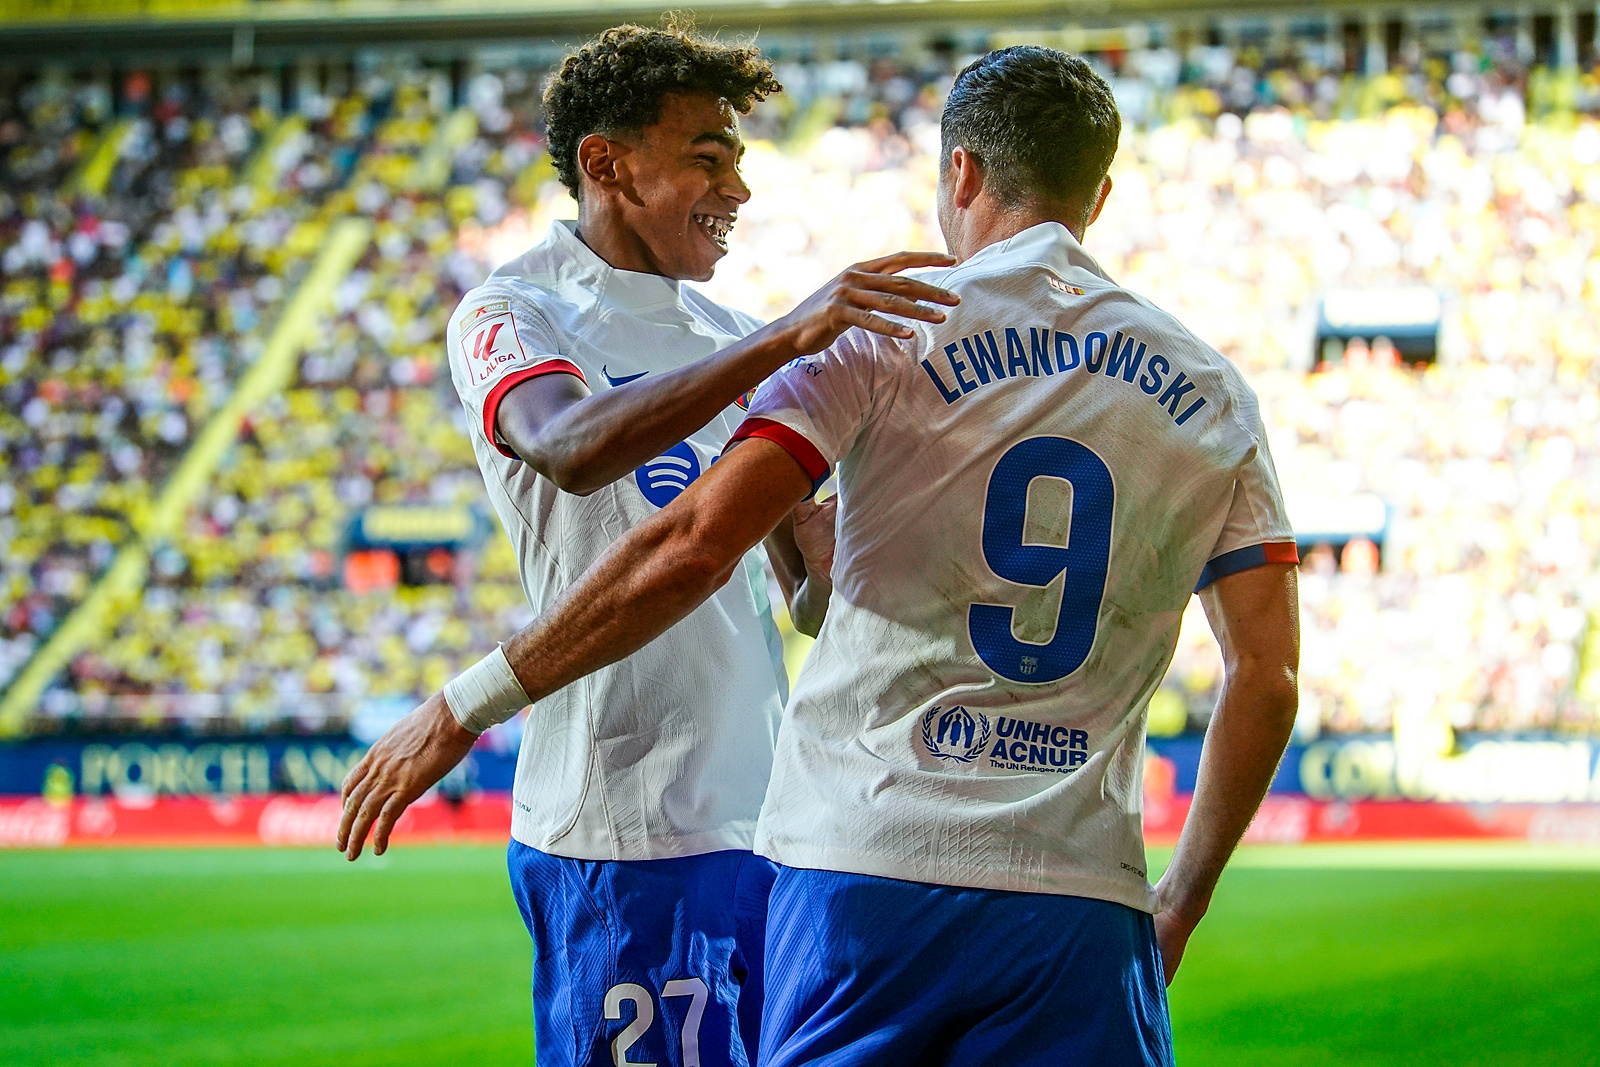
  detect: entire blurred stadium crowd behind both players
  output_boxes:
[0,16,1600,737]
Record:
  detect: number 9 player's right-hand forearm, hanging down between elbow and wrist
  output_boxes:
[1160,667,1296,923]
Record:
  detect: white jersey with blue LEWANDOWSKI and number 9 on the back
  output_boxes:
[734,222,1296,910]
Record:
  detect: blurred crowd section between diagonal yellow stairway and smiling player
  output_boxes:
[37,73,536,726]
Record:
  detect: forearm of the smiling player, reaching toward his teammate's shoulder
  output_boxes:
[518,323,795,494]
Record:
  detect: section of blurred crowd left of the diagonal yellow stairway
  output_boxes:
[0,74,435,700]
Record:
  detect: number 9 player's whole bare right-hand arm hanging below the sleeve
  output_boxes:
[1155,563,1299,984]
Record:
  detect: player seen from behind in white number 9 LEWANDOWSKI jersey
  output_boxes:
[409,46,1299,1067]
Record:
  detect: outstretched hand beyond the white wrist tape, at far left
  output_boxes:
[338,693,478,861]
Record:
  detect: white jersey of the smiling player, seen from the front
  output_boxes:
[446,222,787,859]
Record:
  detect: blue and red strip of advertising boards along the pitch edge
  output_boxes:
[0,731,1600,848]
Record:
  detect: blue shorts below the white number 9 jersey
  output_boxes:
[760,867,1173,1067]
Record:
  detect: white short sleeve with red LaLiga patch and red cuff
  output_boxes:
[446,286,587,459]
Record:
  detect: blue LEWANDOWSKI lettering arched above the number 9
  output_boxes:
[922,326,1206,426]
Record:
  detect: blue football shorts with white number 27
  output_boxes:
[507,841,778,1067]
